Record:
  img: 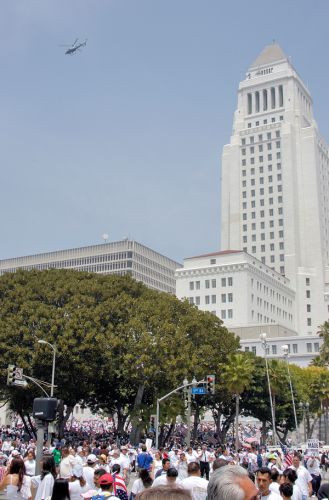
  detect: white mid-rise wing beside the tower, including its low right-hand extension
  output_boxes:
[176,250,323,366]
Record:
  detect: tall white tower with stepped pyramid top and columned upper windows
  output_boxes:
[221,44,329,335]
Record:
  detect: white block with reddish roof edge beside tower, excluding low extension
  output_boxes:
[176,250,295,331]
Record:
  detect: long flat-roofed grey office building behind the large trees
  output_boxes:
[0,239,181,294]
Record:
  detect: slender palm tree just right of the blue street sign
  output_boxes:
[223,353,254,451]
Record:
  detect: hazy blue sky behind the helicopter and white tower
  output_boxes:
[0,0,329,261]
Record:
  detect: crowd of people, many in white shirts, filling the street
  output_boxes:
[0,433,329,500]
